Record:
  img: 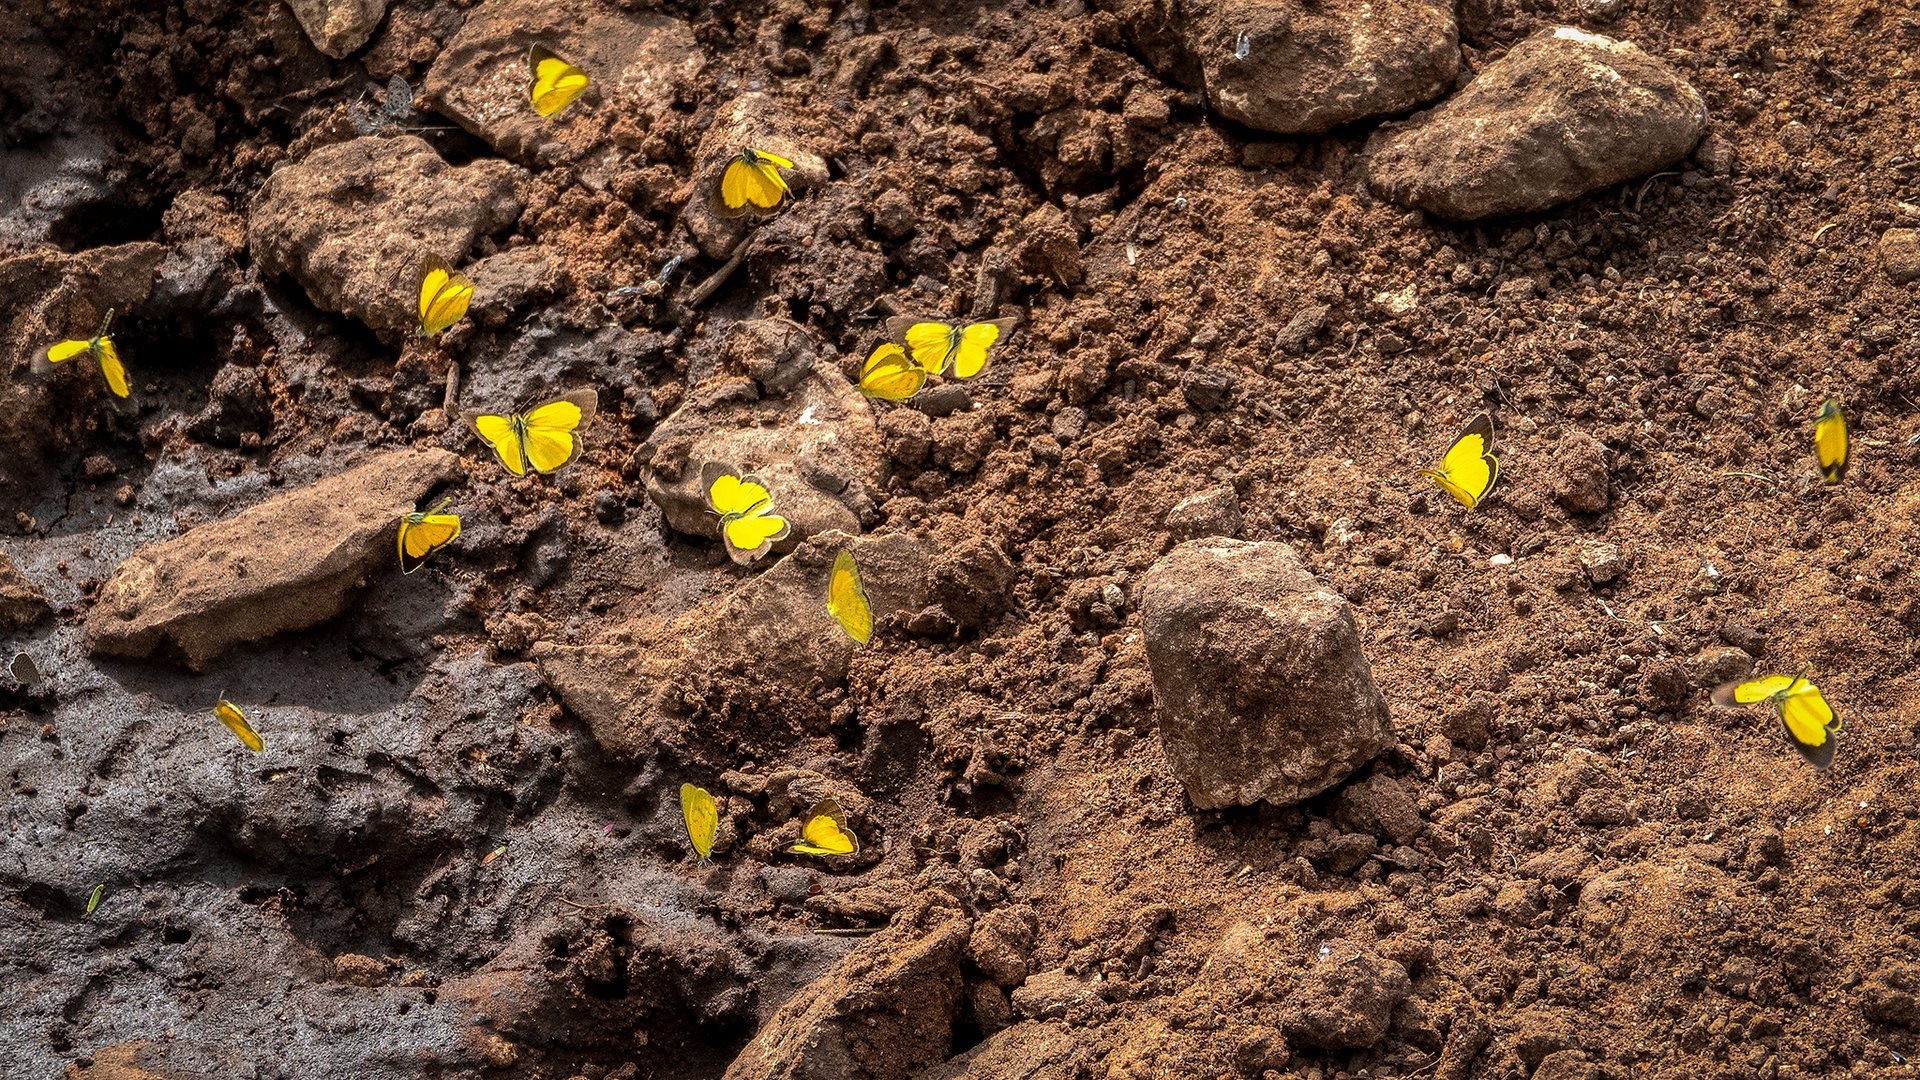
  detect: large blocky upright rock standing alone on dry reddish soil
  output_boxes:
[1140,538,1388,809]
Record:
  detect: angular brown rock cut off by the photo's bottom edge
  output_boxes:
[726,897,968,1080]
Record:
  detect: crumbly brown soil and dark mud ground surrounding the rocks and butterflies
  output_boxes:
[0,0,1920,1080]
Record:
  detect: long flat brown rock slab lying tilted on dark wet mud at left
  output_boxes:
[86,450,461,671]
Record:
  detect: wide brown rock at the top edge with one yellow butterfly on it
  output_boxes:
[424,0,705,163]
